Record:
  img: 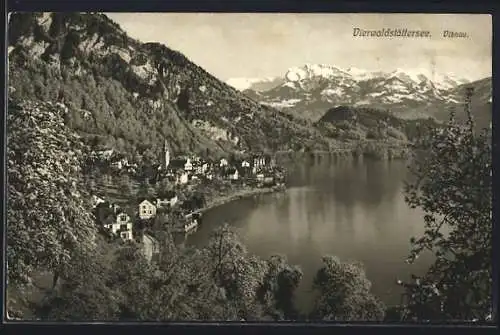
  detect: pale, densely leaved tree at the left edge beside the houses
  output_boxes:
[7,101,95,282]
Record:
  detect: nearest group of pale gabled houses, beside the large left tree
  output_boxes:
[92,192,179,240]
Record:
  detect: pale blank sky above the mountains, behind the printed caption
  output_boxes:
[107,13,492,80]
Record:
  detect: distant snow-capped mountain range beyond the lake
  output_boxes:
[244,64,491,120]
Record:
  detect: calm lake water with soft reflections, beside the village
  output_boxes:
[187,157,431,310]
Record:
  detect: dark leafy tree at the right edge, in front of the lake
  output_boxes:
[398,101,492,320]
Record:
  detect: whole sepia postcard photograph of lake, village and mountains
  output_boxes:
[4,12,496,323]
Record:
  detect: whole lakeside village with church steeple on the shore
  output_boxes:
[88,142,285,249]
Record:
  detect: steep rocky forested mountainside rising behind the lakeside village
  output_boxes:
[8,13,327,161]
